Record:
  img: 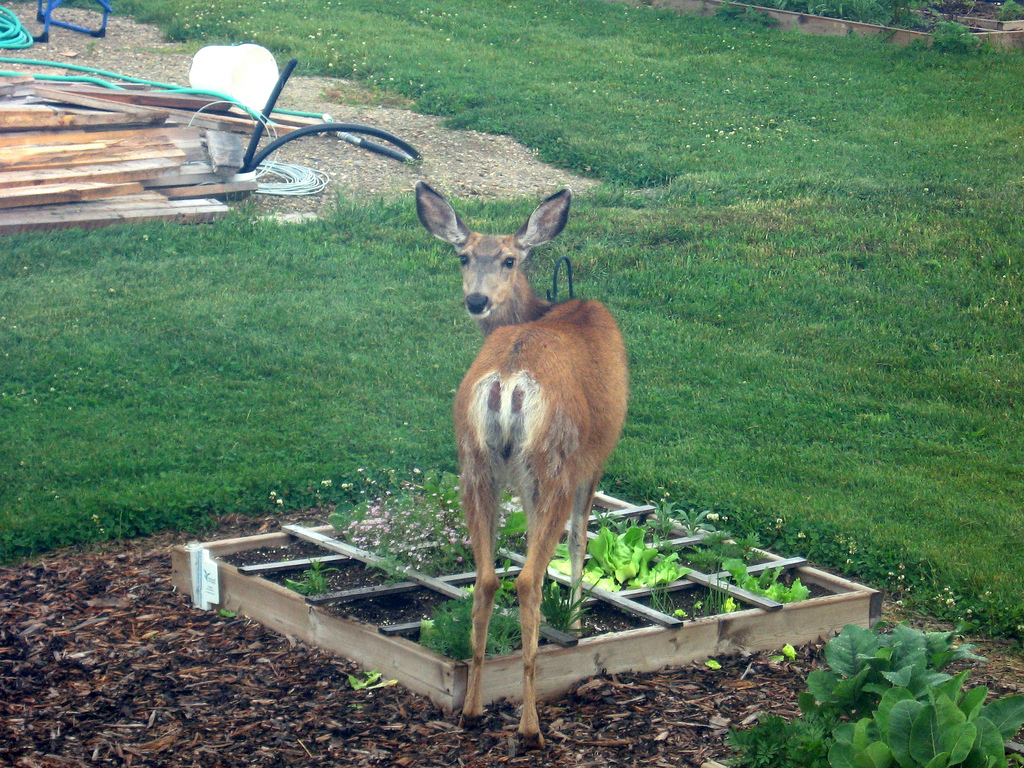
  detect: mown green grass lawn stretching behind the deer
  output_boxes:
[0,0,1024,636]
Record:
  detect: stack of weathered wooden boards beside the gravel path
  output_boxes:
[0,76,288,234]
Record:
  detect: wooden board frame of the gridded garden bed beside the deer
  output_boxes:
[171,495,882,710]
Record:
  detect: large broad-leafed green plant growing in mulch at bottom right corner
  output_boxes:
[729,625,1024,768]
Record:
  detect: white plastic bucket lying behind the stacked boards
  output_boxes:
[188,43,278,112]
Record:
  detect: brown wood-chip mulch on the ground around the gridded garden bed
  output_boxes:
[0,516,1022,768]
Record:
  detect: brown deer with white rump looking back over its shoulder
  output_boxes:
[416,181,629,749]
